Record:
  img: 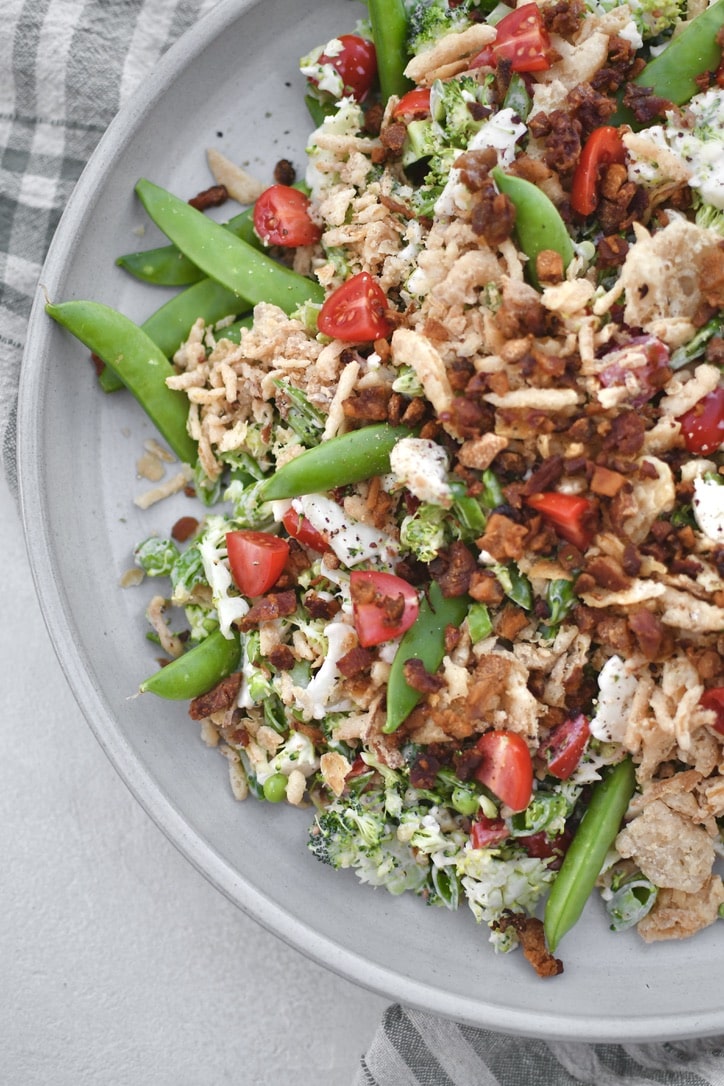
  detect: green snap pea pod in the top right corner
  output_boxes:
[634,0,724,110]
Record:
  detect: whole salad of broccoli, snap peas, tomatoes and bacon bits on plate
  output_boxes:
[47,0,724,976]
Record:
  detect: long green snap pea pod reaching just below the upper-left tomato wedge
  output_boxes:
[136,178,325,313]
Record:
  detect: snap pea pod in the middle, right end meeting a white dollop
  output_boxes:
[261,422,411,502]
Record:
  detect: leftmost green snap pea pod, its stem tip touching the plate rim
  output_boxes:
[46,301,196,464]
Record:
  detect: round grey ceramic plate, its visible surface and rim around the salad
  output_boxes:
[20,0,724,1040]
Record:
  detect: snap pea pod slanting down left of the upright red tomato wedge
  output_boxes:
[491,166,573,290]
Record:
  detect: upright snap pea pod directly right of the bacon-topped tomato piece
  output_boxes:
[382,581,470,735]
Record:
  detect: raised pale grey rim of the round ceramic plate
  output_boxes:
[17,0,724,1043]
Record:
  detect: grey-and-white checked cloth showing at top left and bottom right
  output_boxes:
[0,0,724,1086]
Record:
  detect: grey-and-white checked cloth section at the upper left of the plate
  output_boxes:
[0,0,215,490]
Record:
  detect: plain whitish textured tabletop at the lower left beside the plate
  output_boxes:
[0,479,386,1086]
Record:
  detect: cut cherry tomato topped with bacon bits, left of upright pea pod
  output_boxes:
[350,569,420,648]
